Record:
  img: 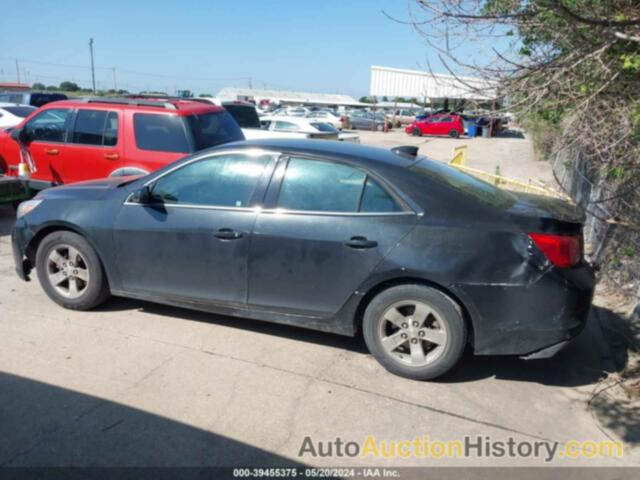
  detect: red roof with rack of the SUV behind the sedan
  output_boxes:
[38,97,224,115]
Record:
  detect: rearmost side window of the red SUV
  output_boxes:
[133,113,190,153]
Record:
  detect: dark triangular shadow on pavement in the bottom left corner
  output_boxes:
[0,373,301,466]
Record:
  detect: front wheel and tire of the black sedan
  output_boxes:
[36,231,111,310]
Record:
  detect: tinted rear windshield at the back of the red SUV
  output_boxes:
[186,111,244,150]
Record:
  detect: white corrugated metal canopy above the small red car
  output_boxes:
[370,65,497,103]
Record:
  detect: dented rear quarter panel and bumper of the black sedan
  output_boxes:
[376,219,590,354]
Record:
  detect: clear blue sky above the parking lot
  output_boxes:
[0,0,464,96]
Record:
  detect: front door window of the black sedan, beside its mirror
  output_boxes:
[152,154,270,208]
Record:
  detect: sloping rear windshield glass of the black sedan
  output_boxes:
[409,159,516,208]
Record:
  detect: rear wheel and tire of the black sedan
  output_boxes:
[362,285,467,380]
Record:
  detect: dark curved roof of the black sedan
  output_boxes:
[216,138,422,168]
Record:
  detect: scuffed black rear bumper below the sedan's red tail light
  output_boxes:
[458,265,595,358]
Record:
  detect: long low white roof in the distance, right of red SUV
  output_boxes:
[216,87,369,107]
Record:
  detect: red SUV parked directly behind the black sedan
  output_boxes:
[0,98,244,190]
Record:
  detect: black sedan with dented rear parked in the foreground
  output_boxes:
[12,140,594,379]
